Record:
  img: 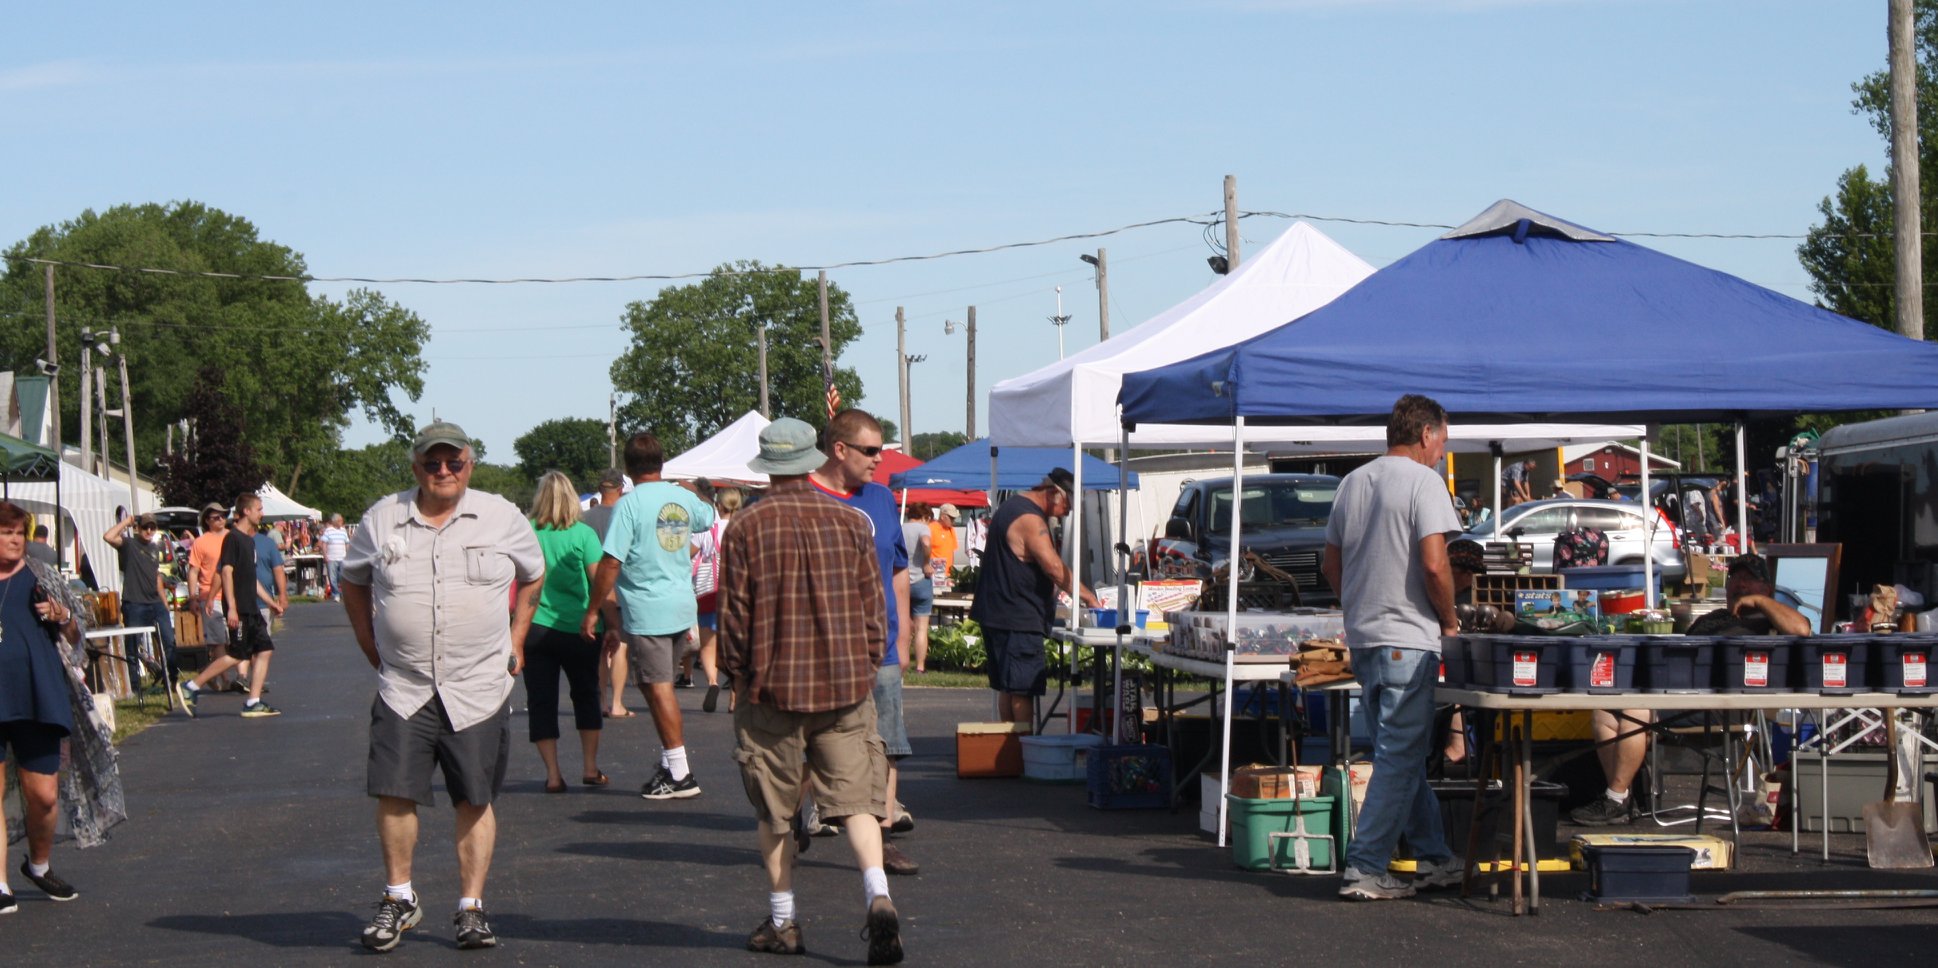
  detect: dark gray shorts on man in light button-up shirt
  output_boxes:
[366,696,512,807]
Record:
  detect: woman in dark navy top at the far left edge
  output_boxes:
[0,502,81,914]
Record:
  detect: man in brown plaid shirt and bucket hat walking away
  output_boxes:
[719,417,901,964]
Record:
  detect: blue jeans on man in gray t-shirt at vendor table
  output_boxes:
[1345,648,1454,873]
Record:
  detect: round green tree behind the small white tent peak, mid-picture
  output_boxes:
[612,262,860,456]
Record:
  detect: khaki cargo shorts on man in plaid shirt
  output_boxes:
[733,696,888,834]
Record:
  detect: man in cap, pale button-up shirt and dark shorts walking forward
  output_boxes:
[343,421,545,951]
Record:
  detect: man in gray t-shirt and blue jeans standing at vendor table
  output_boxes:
[1320,394,1463,900]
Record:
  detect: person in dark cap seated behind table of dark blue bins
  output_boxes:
[1570,555,1810,826]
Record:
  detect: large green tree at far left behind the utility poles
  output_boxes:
[0,202,430,497]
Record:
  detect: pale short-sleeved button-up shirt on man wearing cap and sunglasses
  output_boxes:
[343,487,545,729]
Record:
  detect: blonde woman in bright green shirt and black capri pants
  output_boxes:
[525,471,612,793]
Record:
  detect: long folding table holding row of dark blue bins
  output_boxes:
[1434,687,1938,914]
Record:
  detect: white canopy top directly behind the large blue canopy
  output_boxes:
[988,221,1372,446]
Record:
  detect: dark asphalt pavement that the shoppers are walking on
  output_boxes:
[0,605,1938,968]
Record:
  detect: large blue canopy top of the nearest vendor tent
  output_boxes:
[1118,202,1938,425]
